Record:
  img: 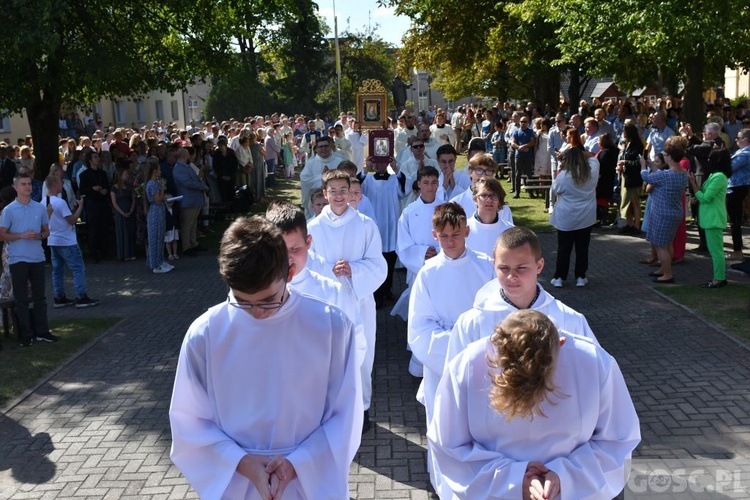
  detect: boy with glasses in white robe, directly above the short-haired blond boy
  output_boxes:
[466,177,513,256]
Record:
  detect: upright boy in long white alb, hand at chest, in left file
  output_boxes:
[307,170,387,432]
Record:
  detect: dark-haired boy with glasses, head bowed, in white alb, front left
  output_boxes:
[169,217,362,500]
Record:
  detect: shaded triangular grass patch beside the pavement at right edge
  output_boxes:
[656,283,750,339]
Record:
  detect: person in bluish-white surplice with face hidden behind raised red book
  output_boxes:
[357,156,412,307]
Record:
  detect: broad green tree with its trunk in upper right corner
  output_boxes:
[544,0,750,126]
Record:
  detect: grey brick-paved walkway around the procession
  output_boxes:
[0,226,750,499]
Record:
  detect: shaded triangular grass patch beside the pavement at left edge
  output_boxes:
[0,317,120,408]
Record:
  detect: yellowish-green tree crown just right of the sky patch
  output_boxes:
[388,0,559,108]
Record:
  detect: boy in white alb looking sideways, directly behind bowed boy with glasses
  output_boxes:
[266,200,367,364]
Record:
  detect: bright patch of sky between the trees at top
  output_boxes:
[315,0,410,47]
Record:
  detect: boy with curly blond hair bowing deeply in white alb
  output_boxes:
[427,310,641,500]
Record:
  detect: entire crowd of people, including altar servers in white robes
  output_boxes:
[0,94,750,499]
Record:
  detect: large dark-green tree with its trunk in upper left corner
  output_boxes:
[0,0,222,176]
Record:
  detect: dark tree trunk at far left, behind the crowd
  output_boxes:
[26,94,62,180]
